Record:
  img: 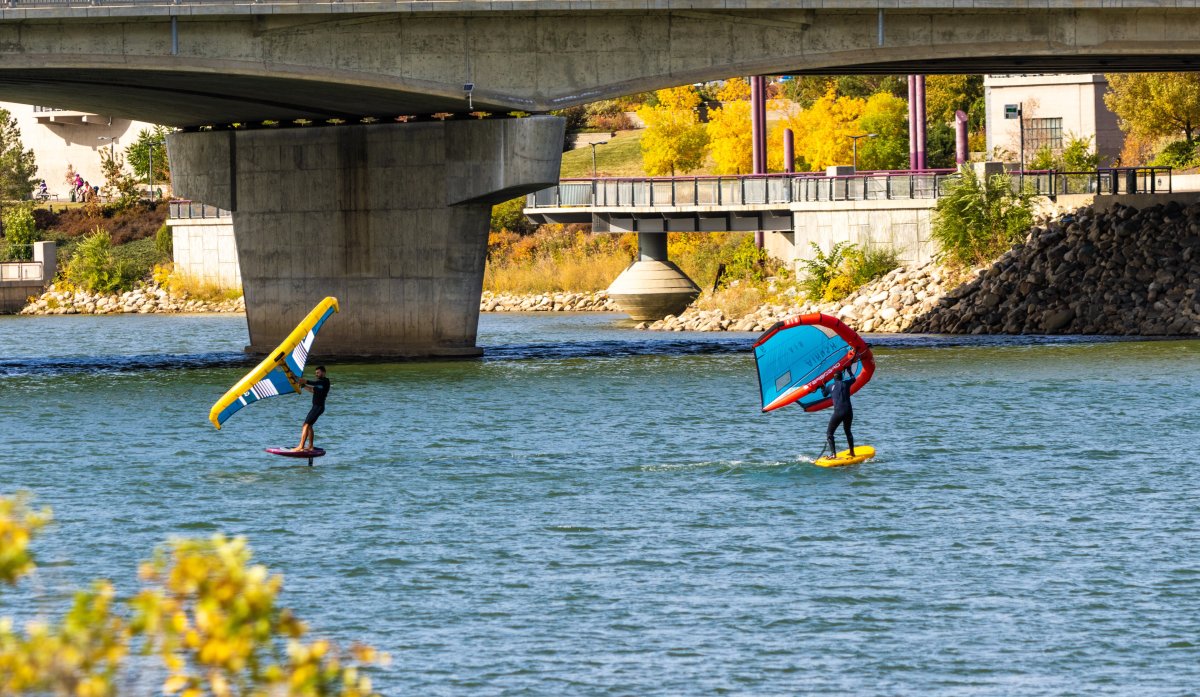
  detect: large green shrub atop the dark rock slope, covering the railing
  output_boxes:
[931,169,1033,266]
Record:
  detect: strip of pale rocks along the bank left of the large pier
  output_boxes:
[20,283,246,314]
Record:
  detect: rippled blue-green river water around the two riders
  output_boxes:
[0,314,1200,695]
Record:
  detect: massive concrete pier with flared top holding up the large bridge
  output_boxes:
[168,116,564,356]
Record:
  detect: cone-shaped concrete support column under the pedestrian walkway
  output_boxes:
[608,233,700,322]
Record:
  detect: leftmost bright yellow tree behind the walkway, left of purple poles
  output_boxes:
[637,85,708,176]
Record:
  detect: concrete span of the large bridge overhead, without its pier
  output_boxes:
[0,8,1200,128]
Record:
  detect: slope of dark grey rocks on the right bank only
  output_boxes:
[910,202,1200,336]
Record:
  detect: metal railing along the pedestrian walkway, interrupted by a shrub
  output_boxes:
[526,167,1171,209]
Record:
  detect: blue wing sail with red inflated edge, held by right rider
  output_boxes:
[754,313,875,411]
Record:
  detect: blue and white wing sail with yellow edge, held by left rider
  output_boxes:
[209,298,340,428]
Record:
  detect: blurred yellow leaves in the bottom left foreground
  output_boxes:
[0,495,388,697]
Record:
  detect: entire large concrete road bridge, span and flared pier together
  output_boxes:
[0,0,1200,355]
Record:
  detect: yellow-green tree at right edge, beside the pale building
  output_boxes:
[1104,73,1200,143]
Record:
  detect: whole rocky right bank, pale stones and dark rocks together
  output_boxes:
[637,202,1200,336]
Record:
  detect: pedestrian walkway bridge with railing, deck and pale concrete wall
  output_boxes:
[524,167,1171,263]
